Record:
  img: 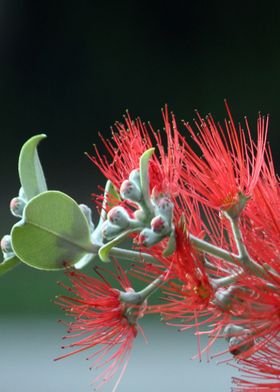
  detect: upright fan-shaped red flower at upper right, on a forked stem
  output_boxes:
[182,104,268,210]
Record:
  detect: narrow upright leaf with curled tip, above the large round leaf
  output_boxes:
[18,134,47,200]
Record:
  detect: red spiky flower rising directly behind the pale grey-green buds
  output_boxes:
[89,106,187,194]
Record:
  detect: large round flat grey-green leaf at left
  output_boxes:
[11,191,97,270]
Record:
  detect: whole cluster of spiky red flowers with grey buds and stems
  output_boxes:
[55,104,280,391]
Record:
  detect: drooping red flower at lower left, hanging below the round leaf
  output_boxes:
[56,266,143,391]
